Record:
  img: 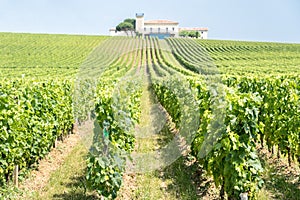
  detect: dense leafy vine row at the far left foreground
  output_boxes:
[0,79,74,185]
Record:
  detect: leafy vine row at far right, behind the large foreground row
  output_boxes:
[226,76,300,165]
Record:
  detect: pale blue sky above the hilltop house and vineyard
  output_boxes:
[0,0,300,43]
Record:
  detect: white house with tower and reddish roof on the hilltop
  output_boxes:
[109,13,208,39]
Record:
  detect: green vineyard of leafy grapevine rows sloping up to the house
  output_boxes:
[0,33,300,199]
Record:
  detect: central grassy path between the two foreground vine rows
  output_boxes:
[117,76,204,200]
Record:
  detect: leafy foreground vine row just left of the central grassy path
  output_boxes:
[86,77,141,199]
